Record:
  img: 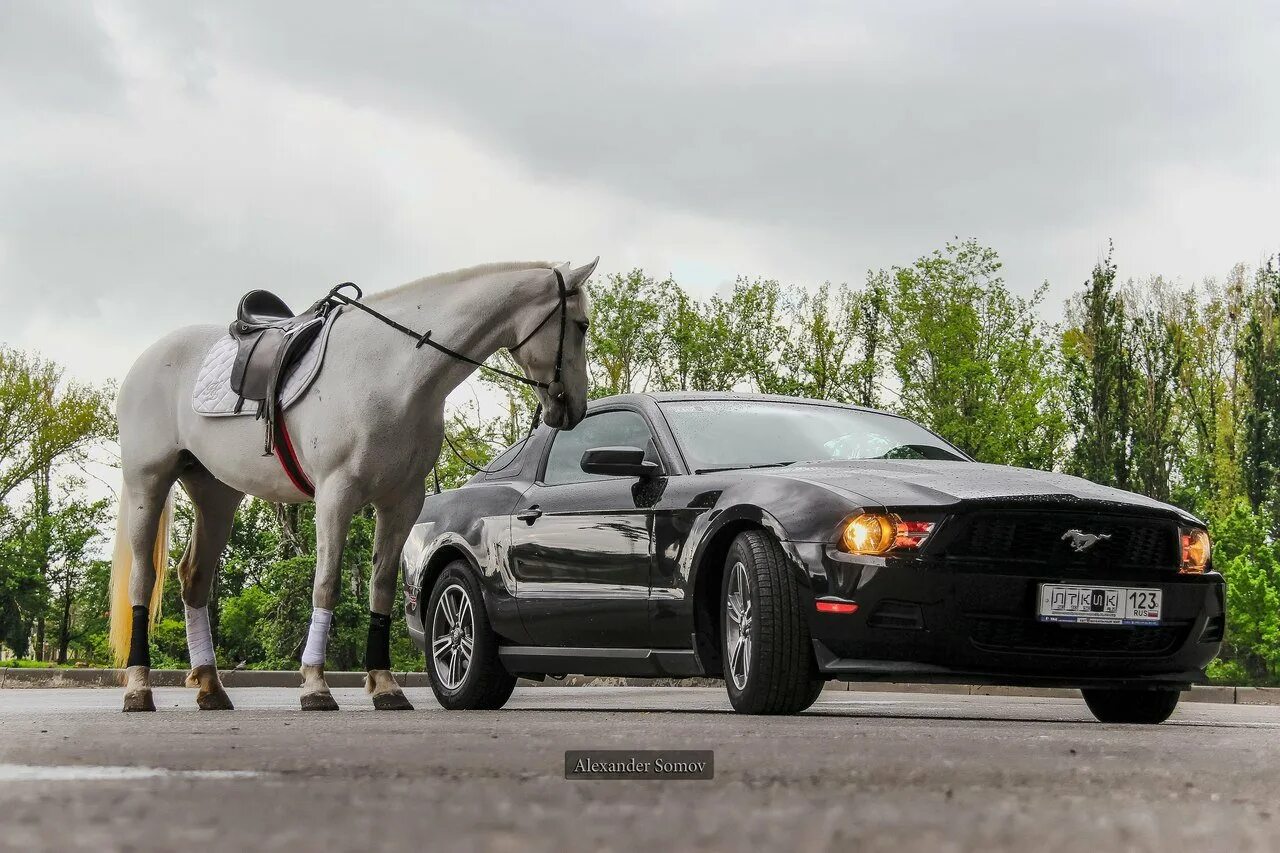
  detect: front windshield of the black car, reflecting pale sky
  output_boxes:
[659,400,964,471]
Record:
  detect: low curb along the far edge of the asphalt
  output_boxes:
[0,667,1280,704]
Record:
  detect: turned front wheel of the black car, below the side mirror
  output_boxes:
[719,530,823,713]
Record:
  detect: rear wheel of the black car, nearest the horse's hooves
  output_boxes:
[422,560,516,711]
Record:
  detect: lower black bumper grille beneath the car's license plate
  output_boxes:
[969,617,1187,654]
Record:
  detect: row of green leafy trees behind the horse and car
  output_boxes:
[0,241,1280,684]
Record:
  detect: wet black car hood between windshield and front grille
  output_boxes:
[762,460,1193,520]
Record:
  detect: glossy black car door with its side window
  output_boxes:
[509,409,657,648]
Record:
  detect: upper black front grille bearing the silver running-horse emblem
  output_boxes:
[945,511,1178,570]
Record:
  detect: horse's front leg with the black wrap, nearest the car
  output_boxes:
[365,480,422,711]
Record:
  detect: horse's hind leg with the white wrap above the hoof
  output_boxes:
[178,467,244,711]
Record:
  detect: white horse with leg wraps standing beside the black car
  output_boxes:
[111,259,599,711]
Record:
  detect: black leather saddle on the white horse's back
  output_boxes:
[230,291,333,455]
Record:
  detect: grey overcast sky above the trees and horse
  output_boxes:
[0,0,1280,379]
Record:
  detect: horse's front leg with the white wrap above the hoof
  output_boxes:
[301,479,358,711]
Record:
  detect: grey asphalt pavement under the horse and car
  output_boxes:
[0,688,1280,853]
